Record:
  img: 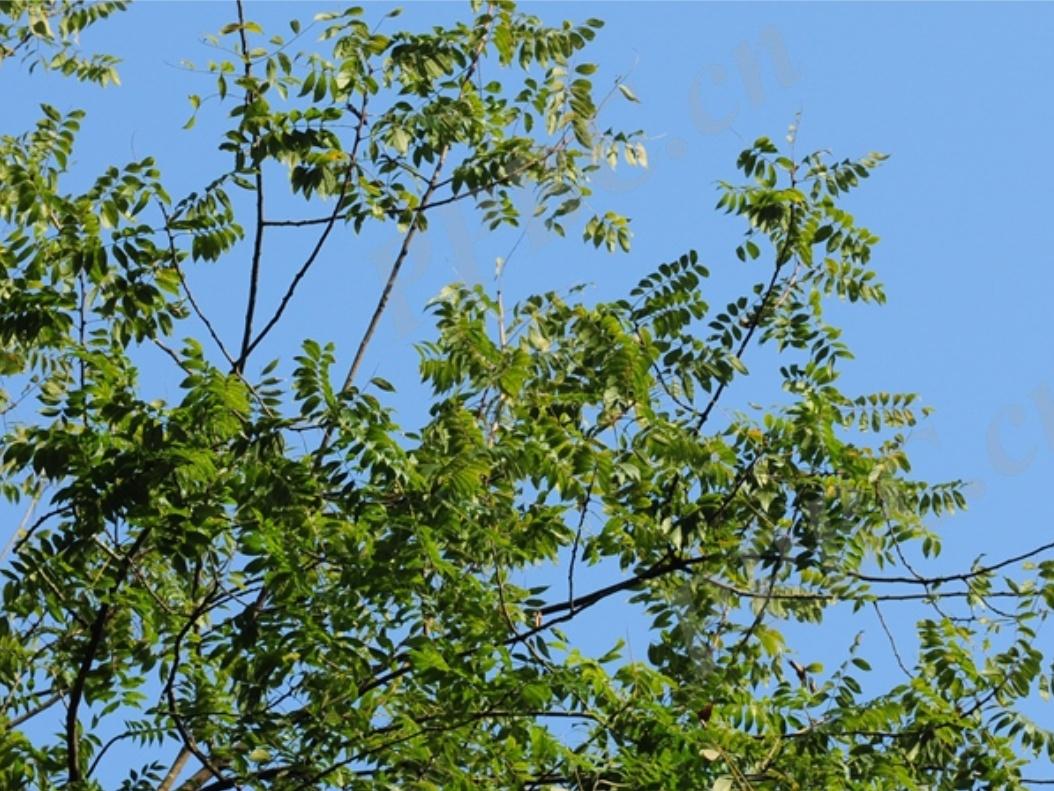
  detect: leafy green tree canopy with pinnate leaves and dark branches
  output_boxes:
[0,0,1054,791]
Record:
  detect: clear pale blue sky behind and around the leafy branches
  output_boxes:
[0,0,1054,788]
